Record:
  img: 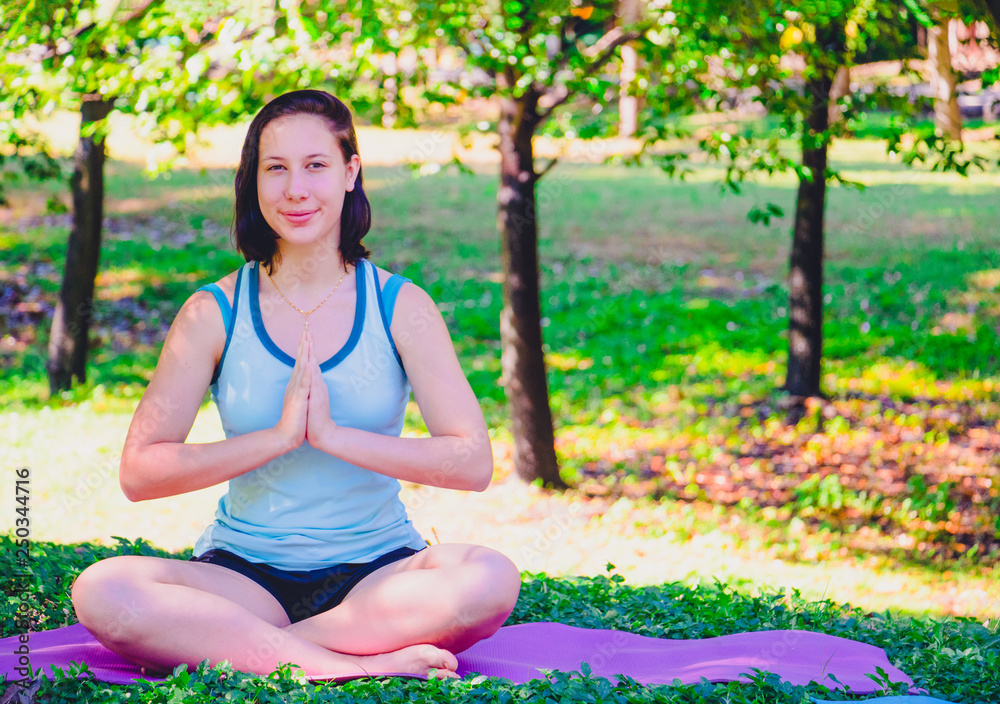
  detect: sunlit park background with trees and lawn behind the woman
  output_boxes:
[0,0,1000,619]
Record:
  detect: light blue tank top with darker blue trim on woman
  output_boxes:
[194,260,427,570]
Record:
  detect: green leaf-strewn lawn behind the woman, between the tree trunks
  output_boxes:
[0,151,1000,569]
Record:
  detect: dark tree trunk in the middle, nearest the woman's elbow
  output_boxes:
[497,89,566,488]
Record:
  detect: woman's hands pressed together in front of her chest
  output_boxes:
[275,328,337,449]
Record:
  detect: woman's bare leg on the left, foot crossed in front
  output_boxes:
[73,556,457,677]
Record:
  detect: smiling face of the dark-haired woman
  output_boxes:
[257,115,361,258]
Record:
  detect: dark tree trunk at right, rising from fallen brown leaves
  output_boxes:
[785,73,833,397]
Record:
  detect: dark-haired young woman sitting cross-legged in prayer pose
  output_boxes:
[73,90,520,678]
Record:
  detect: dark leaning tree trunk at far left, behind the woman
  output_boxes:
[47,95,111,394]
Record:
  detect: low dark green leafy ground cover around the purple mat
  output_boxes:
[0,536,1000,704]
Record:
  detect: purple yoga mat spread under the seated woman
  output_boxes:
[0,623,916,694]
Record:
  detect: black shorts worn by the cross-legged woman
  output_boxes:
[191,548,419,623]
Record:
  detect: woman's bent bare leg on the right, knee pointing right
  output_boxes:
[284,544,521,655]
